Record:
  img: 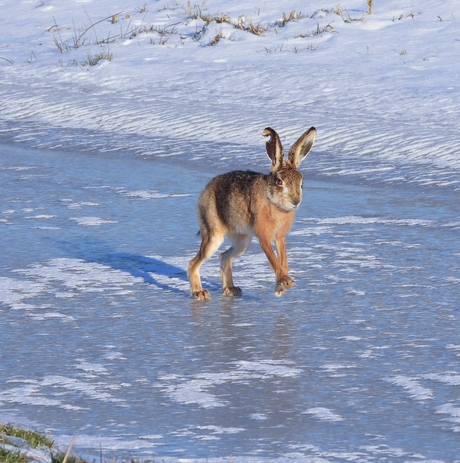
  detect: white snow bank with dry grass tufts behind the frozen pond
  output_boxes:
[0,0,460,187]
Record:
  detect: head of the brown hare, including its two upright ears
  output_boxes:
[263,127,316,211]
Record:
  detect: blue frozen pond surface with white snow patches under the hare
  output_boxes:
[0,136,460,462]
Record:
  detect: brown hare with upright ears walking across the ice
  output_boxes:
[188,127,316,301]
